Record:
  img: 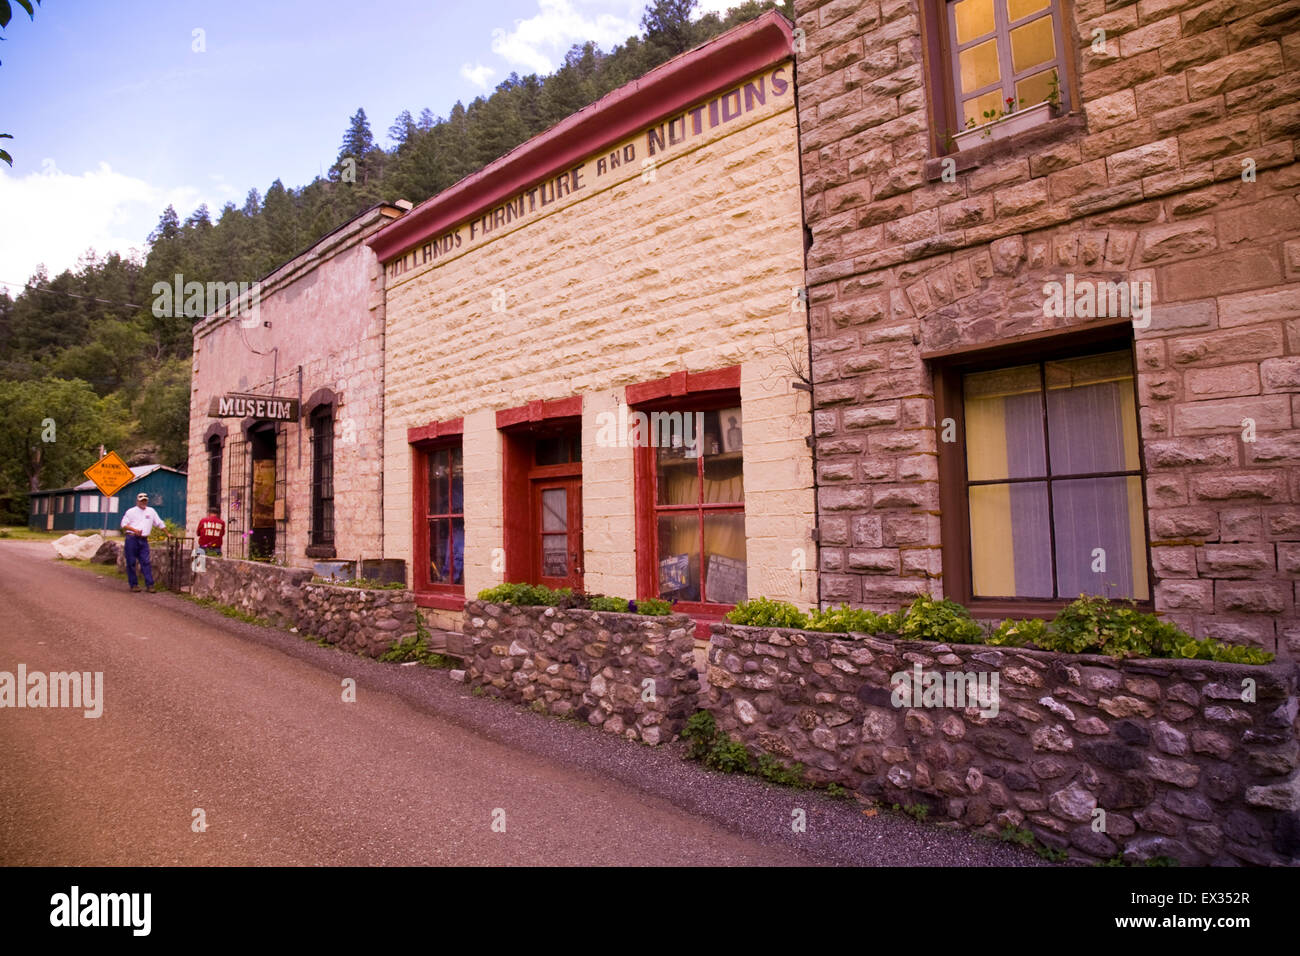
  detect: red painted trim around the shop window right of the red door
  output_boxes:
[634,365,745,624]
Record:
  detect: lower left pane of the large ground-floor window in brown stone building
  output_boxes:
[970,481,1053,597]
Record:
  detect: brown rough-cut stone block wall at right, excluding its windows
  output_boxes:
[796,0,1300,656]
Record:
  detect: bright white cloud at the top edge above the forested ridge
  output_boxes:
[491,0,641,73]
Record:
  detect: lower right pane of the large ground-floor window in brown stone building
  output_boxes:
[1052,476,1148,601]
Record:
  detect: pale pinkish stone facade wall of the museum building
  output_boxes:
[187,211,391,567]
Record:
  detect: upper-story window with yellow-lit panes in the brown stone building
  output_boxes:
[944,0,1067,131]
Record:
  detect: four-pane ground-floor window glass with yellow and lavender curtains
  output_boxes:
[962,351,1149,601]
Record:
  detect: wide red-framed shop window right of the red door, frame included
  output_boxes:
[627,367,748,622]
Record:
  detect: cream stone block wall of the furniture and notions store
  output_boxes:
[384,57,815,606]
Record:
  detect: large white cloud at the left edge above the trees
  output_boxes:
[0,160,235,286]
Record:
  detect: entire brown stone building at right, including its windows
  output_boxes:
[796,0,1300,656]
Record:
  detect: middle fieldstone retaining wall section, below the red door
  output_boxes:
[464,601,699,744]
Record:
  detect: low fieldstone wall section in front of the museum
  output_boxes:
[190,558,417,657]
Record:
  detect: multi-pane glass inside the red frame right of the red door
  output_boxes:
[655,406,748,605]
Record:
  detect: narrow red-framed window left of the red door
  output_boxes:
[407,419,465,609]
